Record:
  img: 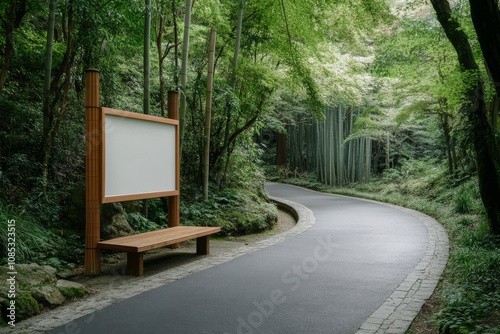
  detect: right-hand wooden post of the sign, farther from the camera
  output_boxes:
[167,91,181,248]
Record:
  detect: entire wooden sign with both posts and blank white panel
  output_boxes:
[84,69,180,275]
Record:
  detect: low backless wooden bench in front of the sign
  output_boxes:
[97,226,220,276]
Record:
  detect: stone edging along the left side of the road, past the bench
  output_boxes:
[0,198,315,334]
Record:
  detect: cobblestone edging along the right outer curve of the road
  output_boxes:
[356,202,449,334]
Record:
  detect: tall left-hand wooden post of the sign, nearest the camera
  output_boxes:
[84,69,102,276]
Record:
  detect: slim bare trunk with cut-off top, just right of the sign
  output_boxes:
[203,28,217,201]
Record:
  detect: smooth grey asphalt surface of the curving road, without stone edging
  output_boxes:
[47,184,429,334]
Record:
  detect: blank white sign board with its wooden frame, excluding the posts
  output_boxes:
[104,113,177,202]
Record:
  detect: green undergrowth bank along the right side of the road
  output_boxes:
[275,161,500,333]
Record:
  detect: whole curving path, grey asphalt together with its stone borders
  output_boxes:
[0,183,448,334]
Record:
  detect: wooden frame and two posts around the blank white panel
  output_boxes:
[83,69,180,276]
